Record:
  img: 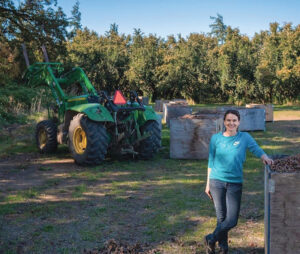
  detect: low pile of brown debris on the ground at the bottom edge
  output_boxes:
[83,239,160,254]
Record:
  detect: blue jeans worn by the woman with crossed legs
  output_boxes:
[209,179,243,249]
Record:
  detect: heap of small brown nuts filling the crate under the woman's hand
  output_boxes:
[270,154,300,173]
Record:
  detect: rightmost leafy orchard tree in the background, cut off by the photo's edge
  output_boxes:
[255,23,300,103]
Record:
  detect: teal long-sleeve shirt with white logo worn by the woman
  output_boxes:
[208,132,265,183]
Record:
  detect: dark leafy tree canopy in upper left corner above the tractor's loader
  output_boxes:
[0,0,74,75]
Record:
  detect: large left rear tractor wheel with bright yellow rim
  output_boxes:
[69,114,108,165]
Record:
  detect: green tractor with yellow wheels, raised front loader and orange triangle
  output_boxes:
[24,51,161,165]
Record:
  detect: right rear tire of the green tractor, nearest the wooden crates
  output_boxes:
[138,121,161,160]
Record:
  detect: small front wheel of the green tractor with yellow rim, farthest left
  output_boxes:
[35,120,57,153]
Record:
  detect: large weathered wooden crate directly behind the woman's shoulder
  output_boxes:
[170,114,223,159]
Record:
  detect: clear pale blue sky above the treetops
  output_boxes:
[58,0,300,38]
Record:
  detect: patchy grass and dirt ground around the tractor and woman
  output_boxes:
[0,107,300,254]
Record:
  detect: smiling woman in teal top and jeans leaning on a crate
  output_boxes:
[204,110,273,254]
